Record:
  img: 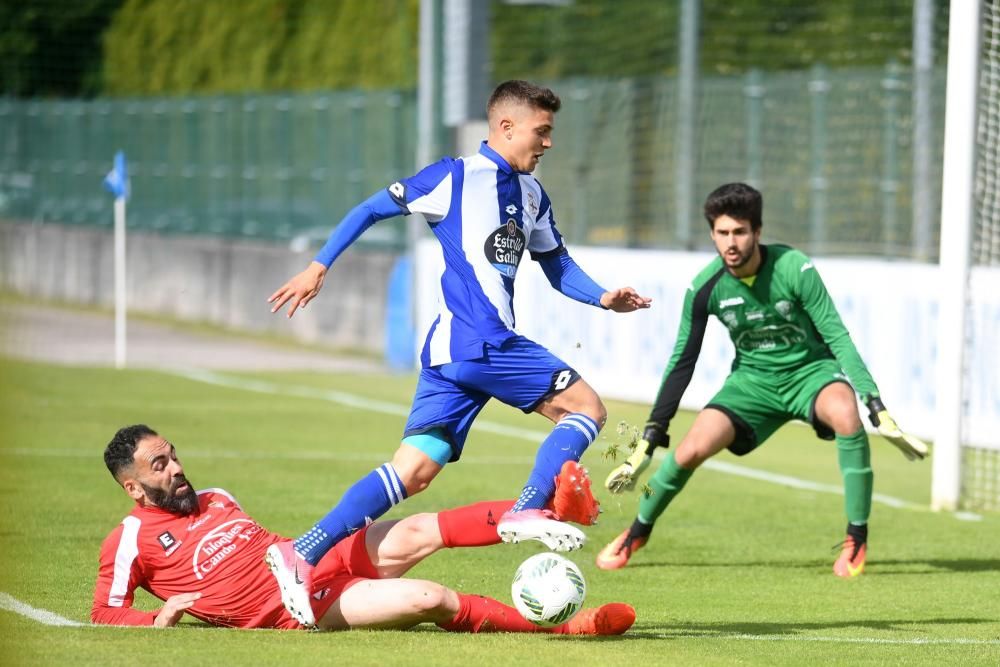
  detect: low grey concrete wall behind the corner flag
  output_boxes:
[0,223,397,353]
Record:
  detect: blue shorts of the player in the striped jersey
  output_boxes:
[403,336,580,461]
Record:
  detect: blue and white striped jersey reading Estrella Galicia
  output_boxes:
[396,141,563,367]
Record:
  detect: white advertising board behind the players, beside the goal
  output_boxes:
[416,239,1000,448]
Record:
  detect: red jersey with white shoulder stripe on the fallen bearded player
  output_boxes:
[90,489,286,627]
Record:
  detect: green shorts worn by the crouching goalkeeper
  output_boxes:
[705,359,850,456]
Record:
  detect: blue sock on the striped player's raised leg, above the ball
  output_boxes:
[511,413,600,512]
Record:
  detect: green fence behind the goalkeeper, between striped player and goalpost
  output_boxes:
[540,64,944,259]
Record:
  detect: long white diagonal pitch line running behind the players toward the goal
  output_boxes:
[164,369,982,521]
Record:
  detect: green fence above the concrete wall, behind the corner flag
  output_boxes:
[0,91,416,247]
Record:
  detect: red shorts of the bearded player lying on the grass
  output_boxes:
[247,526,380,630]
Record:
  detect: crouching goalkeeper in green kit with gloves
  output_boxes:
[597,183,927,577]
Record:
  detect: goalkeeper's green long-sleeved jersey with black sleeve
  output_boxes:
[649,245,878,430]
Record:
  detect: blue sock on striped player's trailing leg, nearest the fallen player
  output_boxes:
[294,463,406,565]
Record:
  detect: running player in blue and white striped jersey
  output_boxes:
[269,81,650,628]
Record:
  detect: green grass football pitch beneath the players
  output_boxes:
[0,361,1000,665]
